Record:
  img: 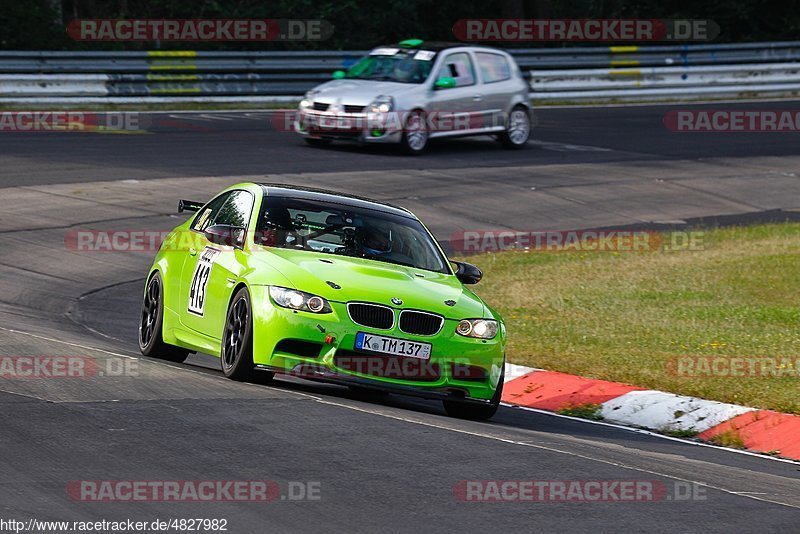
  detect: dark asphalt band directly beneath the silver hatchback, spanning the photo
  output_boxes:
[0,102,800,186]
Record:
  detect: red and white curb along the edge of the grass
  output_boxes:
[503,364,800,460]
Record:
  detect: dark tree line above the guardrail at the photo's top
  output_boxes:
[0,0,800,50]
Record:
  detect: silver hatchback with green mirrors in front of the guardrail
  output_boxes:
[294,39,531,154]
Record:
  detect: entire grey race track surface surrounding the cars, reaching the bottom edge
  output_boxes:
[0,102,800,533]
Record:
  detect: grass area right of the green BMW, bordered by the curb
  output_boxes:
[460,223,800,414]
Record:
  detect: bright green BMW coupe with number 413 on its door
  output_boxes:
[139,183,506,419]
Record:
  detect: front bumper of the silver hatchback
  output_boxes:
[294,110,403,143]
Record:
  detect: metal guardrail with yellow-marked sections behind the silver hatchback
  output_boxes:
[0,41,800,104]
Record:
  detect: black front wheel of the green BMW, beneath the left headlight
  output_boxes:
[219,287,275,382]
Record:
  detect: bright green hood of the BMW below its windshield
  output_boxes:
[251,247,490,319]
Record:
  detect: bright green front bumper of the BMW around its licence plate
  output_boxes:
[251,286,505,401]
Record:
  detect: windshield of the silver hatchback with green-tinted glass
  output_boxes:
[345,48,436,83]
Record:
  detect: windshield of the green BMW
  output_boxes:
[255,196,450,274]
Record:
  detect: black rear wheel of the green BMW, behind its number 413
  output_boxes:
[139,271,189,363]
